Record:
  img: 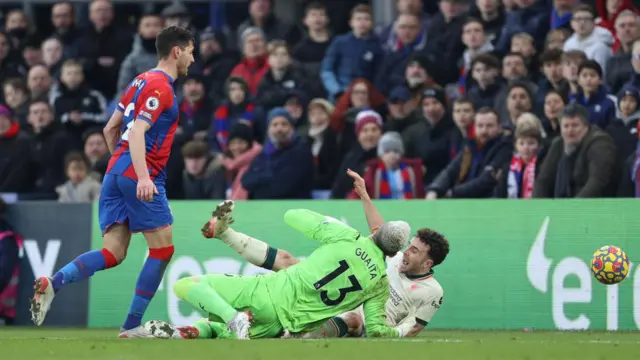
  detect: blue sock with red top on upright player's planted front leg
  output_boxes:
[122,245,173,330]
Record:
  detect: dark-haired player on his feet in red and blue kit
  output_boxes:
[31,26,194,338]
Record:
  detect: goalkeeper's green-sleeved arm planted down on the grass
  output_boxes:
[363,276,404,337]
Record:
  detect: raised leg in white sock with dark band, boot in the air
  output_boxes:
[202,200,300,271]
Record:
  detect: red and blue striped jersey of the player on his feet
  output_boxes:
[107,70,179,184]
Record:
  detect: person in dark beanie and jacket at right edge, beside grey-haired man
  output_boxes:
[606,85,640,159]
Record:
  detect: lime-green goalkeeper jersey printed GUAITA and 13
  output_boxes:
[267,209,398,337]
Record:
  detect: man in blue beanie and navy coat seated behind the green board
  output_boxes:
[242,107,313,199]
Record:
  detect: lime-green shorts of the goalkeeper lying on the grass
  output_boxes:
[201,274,284,339]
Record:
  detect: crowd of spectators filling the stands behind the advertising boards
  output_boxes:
[0,0,640,202]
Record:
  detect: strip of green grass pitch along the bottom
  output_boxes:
[0,327,640,360]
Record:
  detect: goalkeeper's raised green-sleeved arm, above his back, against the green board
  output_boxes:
[284,209,359,244]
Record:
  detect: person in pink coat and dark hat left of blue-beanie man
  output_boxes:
[222,123,262,200]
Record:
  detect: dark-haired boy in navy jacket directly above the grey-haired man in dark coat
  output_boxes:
[570,60,618,130]
